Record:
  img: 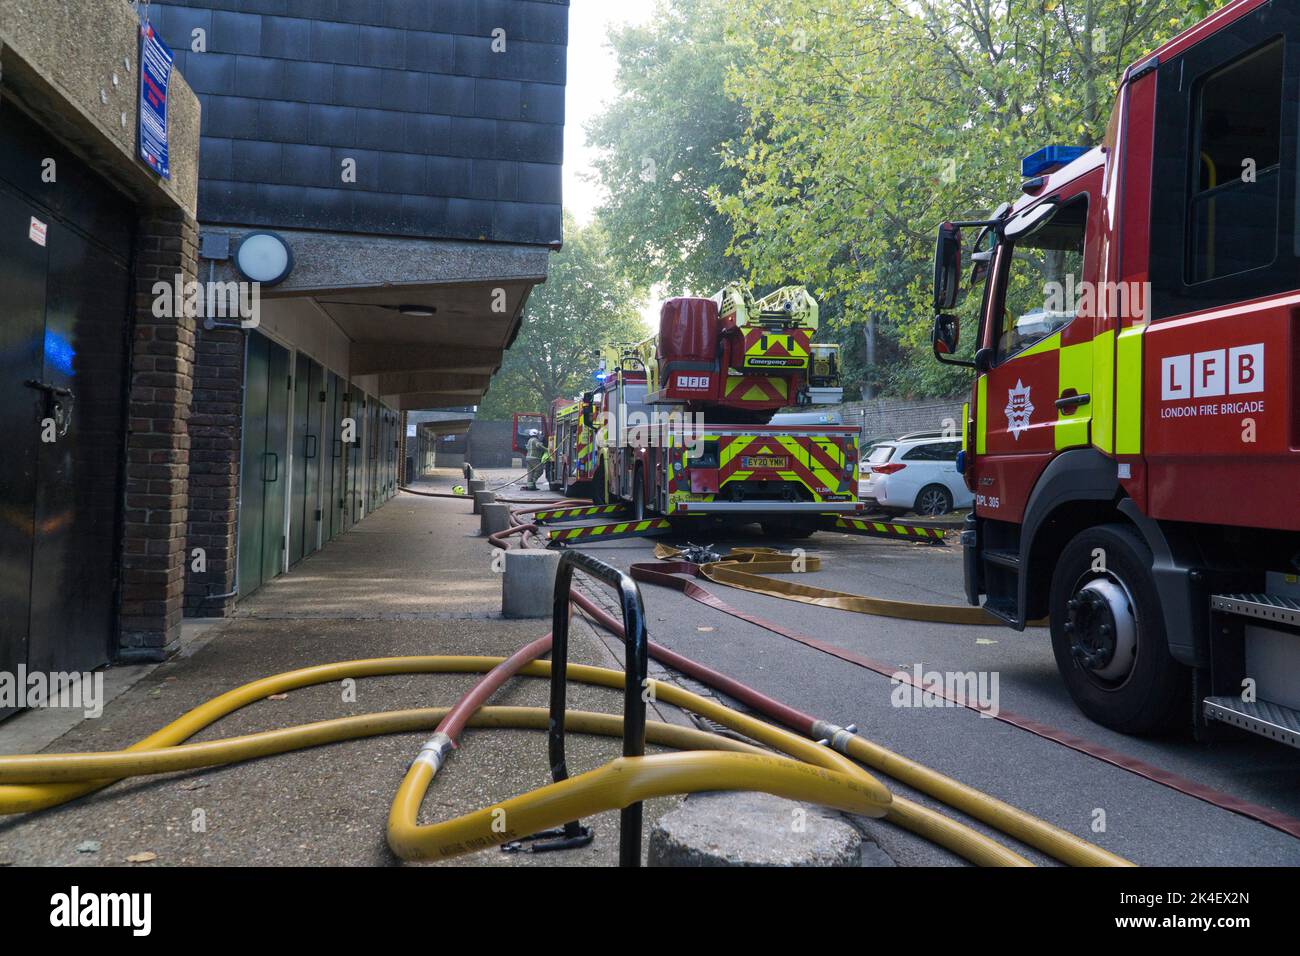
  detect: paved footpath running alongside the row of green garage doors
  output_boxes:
[0,471,672,866]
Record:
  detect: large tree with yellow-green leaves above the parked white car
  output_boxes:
[712,0,1201,394]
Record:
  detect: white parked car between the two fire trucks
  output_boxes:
[858,436,974,515]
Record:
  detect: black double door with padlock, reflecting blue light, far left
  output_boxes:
[0,100,135,715]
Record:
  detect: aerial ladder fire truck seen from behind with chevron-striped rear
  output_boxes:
[551,282,863,537]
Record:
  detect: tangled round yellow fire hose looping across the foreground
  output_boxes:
[0,657,1127,866]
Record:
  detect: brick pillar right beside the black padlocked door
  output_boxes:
[117,209,198,661]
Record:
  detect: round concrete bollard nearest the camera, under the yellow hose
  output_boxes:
[646,792,893,866]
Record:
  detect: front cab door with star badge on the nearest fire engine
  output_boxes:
[974,180,1100,523]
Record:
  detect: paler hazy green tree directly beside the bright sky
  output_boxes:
[586,0,745,295]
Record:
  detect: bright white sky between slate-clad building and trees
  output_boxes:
[564,0,654,222]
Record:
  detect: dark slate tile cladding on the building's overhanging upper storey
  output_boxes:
[150,0,568,243]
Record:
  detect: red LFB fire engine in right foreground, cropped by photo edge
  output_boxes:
[933,0,1300,747]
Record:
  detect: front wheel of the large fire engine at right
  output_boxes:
[1050,524,1190,734]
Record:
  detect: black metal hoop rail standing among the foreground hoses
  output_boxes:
[547,551,650,866]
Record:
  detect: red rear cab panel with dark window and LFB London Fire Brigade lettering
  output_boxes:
[1144,4,1300,532]
